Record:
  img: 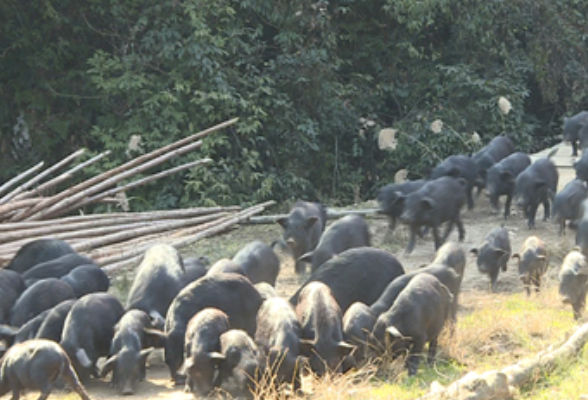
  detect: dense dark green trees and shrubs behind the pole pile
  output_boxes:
[0,0,588,210]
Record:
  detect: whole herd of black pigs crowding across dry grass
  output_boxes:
[5,120,588,400]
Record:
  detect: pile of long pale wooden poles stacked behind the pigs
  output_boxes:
[0,119,273,270]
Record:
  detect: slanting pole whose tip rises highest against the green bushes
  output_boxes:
[12,118,239,221]
